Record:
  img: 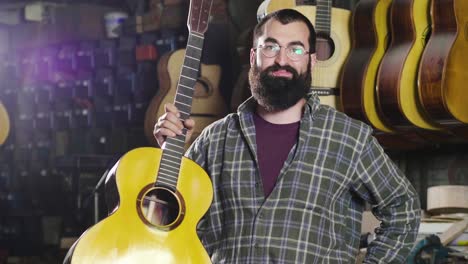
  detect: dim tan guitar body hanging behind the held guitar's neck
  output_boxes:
[145,49,228,147]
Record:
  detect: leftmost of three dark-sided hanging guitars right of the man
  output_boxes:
[340,0,392,132]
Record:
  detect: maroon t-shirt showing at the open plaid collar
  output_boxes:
[254,114,299,197]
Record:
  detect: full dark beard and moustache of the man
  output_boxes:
[249,61,312,112]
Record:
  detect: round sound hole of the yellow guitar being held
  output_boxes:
[141,188,182,229]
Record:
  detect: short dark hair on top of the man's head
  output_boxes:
[253,9,316,53]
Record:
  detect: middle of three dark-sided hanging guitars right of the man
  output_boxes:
[377,0,440,130]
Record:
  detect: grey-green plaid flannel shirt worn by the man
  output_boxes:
[186,95,420,264]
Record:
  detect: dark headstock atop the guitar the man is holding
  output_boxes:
[187,0,213,34]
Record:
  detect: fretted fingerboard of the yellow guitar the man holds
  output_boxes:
[155,32,204,189]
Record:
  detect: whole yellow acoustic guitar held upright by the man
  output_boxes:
[65,0,213,264]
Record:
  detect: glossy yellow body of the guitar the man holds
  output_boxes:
[71,147,213,264]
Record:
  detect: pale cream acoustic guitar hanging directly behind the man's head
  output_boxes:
[257,0,351,110]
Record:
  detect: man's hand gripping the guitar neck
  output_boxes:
[153,103,195,147]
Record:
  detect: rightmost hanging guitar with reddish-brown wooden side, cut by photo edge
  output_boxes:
[418,0,468,127]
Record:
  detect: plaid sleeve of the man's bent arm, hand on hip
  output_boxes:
[354,136,421,263]
